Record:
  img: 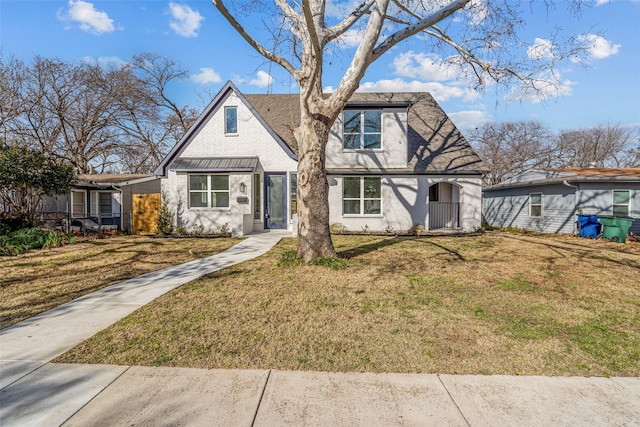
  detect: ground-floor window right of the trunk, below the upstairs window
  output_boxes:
[342,177,382,215]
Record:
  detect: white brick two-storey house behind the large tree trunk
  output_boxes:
[155,82,485,236]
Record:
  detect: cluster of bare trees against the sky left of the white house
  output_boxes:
[0,53,195,173]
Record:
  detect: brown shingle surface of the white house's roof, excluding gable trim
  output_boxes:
[244,92,487,173]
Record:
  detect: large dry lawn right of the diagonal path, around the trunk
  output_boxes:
[48,232,640,376]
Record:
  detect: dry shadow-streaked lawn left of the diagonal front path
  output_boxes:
[0,236,238,328]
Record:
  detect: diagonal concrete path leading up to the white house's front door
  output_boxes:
[0,232,284,389]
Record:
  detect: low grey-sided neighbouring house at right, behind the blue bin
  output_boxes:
[483,168,640,234]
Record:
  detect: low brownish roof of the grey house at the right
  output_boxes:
[484,168,640,191]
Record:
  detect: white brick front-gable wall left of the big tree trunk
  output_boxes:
[162,93,297,236]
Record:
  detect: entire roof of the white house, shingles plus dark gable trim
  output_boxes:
[155,82,487,175]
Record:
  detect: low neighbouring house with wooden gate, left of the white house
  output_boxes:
[42,174,160,232]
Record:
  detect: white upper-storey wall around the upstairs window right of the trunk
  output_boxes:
[326,108,407,169]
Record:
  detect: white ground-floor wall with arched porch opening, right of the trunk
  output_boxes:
[329,176,482,231]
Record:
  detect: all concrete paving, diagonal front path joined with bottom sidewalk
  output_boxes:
[0,234,640,427]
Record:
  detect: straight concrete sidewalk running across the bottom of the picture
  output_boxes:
[0,364,640,427]
